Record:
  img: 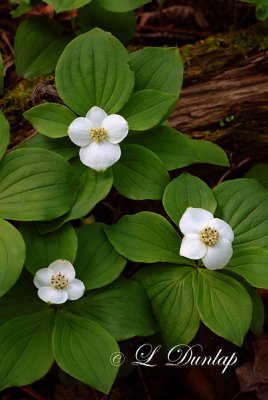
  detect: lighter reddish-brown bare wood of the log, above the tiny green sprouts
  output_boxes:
[170,51,268,134]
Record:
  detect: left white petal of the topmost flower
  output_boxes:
[68,117,93,147]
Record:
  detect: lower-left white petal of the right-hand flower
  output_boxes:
[180,233,207,260]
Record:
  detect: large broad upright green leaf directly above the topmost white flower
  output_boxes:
[56,28,134,116]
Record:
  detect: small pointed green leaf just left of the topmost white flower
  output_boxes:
[23,103,77,138]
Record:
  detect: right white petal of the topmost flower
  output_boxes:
[102,114,128,144]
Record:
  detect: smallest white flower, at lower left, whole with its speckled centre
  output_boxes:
[34,260,85,304]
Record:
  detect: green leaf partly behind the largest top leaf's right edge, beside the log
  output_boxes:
[129,47,183,96]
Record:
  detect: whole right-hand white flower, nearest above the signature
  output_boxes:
[179,207,234,269]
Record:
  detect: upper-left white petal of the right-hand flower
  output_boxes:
[179,207,213,235]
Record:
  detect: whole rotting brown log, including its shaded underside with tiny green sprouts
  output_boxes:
[169,23,268,163]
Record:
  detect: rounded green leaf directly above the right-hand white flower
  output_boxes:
[163,172,217,225]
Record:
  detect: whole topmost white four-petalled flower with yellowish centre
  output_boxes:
[68,106,128,171]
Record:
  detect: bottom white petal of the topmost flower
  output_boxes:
[79,140,121,171]
